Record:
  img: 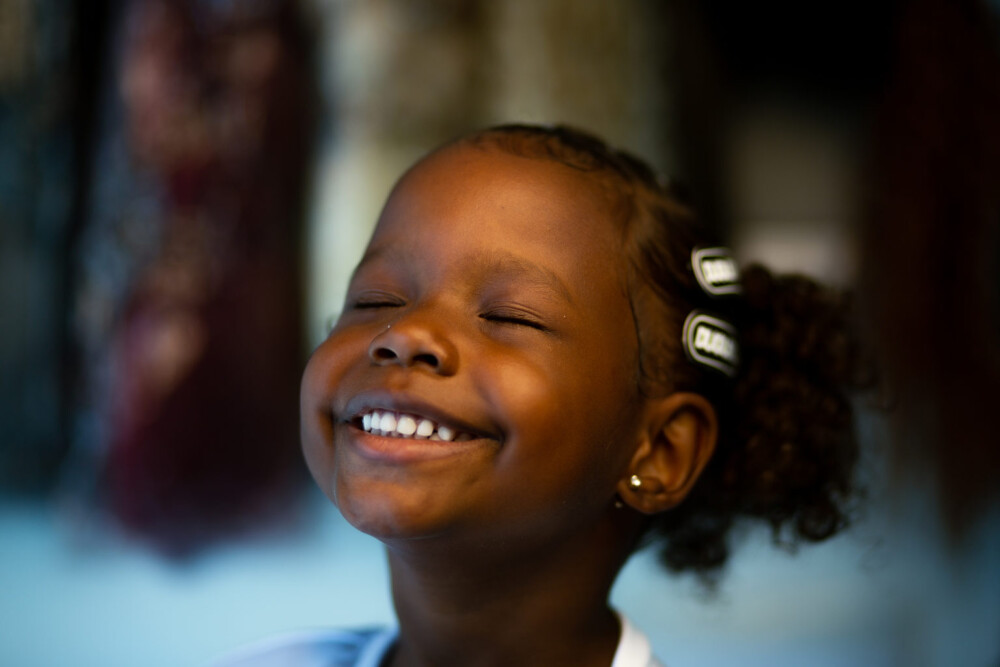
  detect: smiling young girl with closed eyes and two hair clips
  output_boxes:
[223,126,859,667]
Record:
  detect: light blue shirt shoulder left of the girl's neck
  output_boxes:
[212,628,396,667]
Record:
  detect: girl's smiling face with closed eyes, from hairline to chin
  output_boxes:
[301,144,642,544]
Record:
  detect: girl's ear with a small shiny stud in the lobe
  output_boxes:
[618,392,719,514]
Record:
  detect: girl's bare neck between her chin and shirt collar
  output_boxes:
[378,516,634,667]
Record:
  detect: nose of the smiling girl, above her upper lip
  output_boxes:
[368,314,458,375]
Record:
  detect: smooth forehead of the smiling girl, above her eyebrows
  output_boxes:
[371,144,621,280]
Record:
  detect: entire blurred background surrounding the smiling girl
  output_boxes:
[0,0,1000,667]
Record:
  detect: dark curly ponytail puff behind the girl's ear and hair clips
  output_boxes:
[649,265,873,583]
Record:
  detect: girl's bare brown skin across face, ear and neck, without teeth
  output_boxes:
[302,144,714,667]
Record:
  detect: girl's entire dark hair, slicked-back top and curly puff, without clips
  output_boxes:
[464,125,873,583]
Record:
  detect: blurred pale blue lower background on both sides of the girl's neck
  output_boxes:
[0,486,1000,667]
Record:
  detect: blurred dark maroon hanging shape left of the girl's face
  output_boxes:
[106,0,314,553]
